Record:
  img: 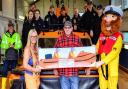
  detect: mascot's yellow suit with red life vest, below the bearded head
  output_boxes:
[97,32,122,89]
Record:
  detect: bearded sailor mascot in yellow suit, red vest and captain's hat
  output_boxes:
[94,6,123,89]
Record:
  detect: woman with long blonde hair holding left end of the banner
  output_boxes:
[23,29,41,89]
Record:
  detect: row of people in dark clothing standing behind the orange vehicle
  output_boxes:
[22,1,103,48]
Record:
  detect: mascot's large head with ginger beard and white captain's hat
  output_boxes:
[101,5,123,36]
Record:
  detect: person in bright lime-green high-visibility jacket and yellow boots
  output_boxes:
[1,20,22,89]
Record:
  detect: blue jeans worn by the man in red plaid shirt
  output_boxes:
[60,76,79,89]
